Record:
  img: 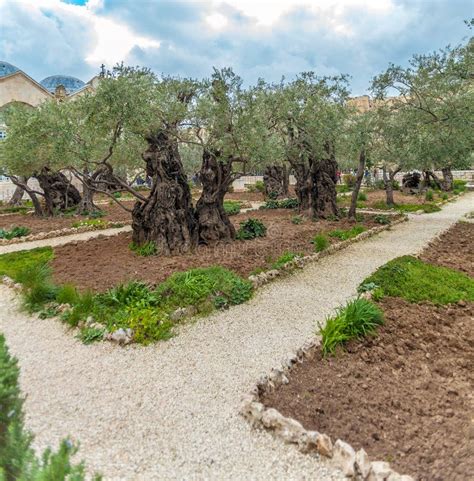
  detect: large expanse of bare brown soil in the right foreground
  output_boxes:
[264,298,474,481]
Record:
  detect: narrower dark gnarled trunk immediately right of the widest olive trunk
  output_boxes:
[196,150,235,245]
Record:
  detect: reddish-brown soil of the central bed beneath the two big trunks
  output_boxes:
[52,209,386,291]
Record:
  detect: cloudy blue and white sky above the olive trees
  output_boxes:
[0,0,474,95]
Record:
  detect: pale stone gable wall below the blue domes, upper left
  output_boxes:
[0,72,52,108]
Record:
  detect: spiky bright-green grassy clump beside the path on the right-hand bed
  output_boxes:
[319,298,383,355]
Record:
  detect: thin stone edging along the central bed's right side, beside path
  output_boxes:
[248,215,408,289]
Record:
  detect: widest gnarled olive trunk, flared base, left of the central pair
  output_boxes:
[132,130,197,255]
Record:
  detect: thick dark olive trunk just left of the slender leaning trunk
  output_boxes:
[310,143,339,219]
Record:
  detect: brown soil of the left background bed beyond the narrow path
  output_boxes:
[0,201,133,234]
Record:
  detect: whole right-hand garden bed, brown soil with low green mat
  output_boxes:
[256,224,474,481]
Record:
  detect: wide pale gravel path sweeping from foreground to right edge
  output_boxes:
[0,194,474,480]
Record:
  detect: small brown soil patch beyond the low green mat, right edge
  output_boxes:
[420,222,474,277]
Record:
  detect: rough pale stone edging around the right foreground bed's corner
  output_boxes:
[240,339,414,481]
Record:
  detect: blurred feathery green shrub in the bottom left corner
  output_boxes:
[0,335,101,481]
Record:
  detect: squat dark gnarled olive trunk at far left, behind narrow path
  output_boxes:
[35,167,81,216]
